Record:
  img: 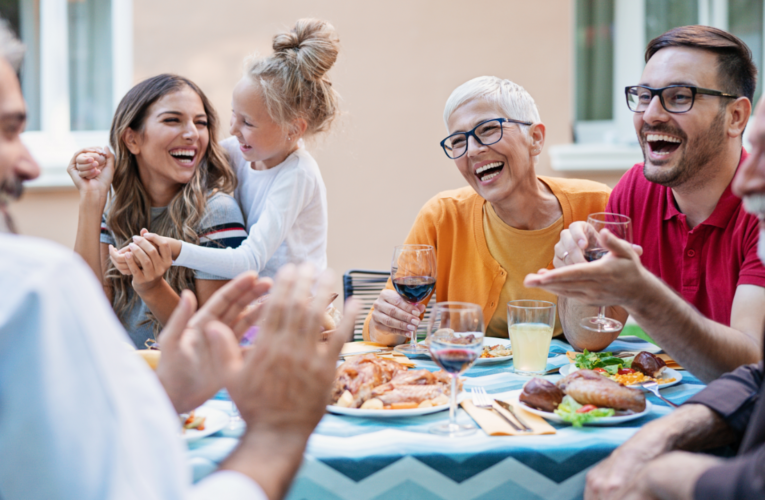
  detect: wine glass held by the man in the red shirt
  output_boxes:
[580,212,632,333]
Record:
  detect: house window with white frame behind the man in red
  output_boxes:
[550,0,765,171]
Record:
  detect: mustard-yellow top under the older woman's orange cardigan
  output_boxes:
[483,203,563,338]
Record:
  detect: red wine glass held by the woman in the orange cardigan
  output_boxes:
[390,245,436,356]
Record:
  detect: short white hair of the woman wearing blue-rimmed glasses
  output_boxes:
[444,76,541,129]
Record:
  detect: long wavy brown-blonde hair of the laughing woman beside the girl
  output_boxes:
[105,74,236,338]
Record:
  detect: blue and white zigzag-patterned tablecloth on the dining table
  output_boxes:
[188,337,704,500]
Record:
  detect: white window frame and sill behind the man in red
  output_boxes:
[550,0,765,172]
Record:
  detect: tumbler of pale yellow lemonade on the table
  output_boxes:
[507,300,555,376]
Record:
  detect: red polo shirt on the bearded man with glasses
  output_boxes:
[607,151,765,326]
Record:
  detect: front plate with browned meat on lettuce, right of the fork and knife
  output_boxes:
[518,369,652,427]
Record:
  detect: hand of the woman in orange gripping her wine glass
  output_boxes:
[369,288,425,345]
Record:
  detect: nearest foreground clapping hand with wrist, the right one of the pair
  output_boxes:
[206,265,359,499]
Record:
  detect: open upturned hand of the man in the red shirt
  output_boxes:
[523,229,648,306]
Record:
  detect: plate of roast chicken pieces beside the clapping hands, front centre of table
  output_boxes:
[327,354,462,418]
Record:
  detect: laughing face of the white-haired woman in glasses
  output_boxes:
[449,99,538,203]
